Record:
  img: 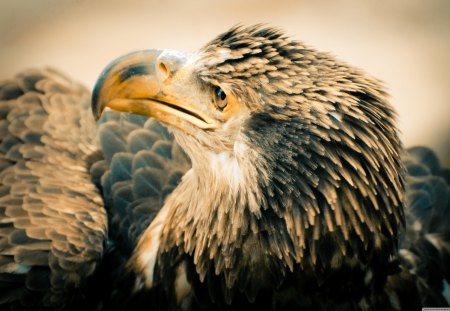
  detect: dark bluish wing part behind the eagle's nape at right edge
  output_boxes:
[400,147,450,306]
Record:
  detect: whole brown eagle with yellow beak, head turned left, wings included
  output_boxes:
[0,24,450,310]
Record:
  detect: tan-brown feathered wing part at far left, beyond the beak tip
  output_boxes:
[0,69,107,309]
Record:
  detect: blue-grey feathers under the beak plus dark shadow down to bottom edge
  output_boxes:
[85,106,190,310]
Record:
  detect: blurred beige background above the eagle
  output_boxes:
[0,0,450,164]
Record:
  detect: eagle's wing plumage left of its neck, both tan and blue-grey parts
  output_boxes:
[0,69,190,309]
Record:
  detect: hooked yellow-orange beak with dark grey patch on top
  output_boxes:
[92,49,218,130]
